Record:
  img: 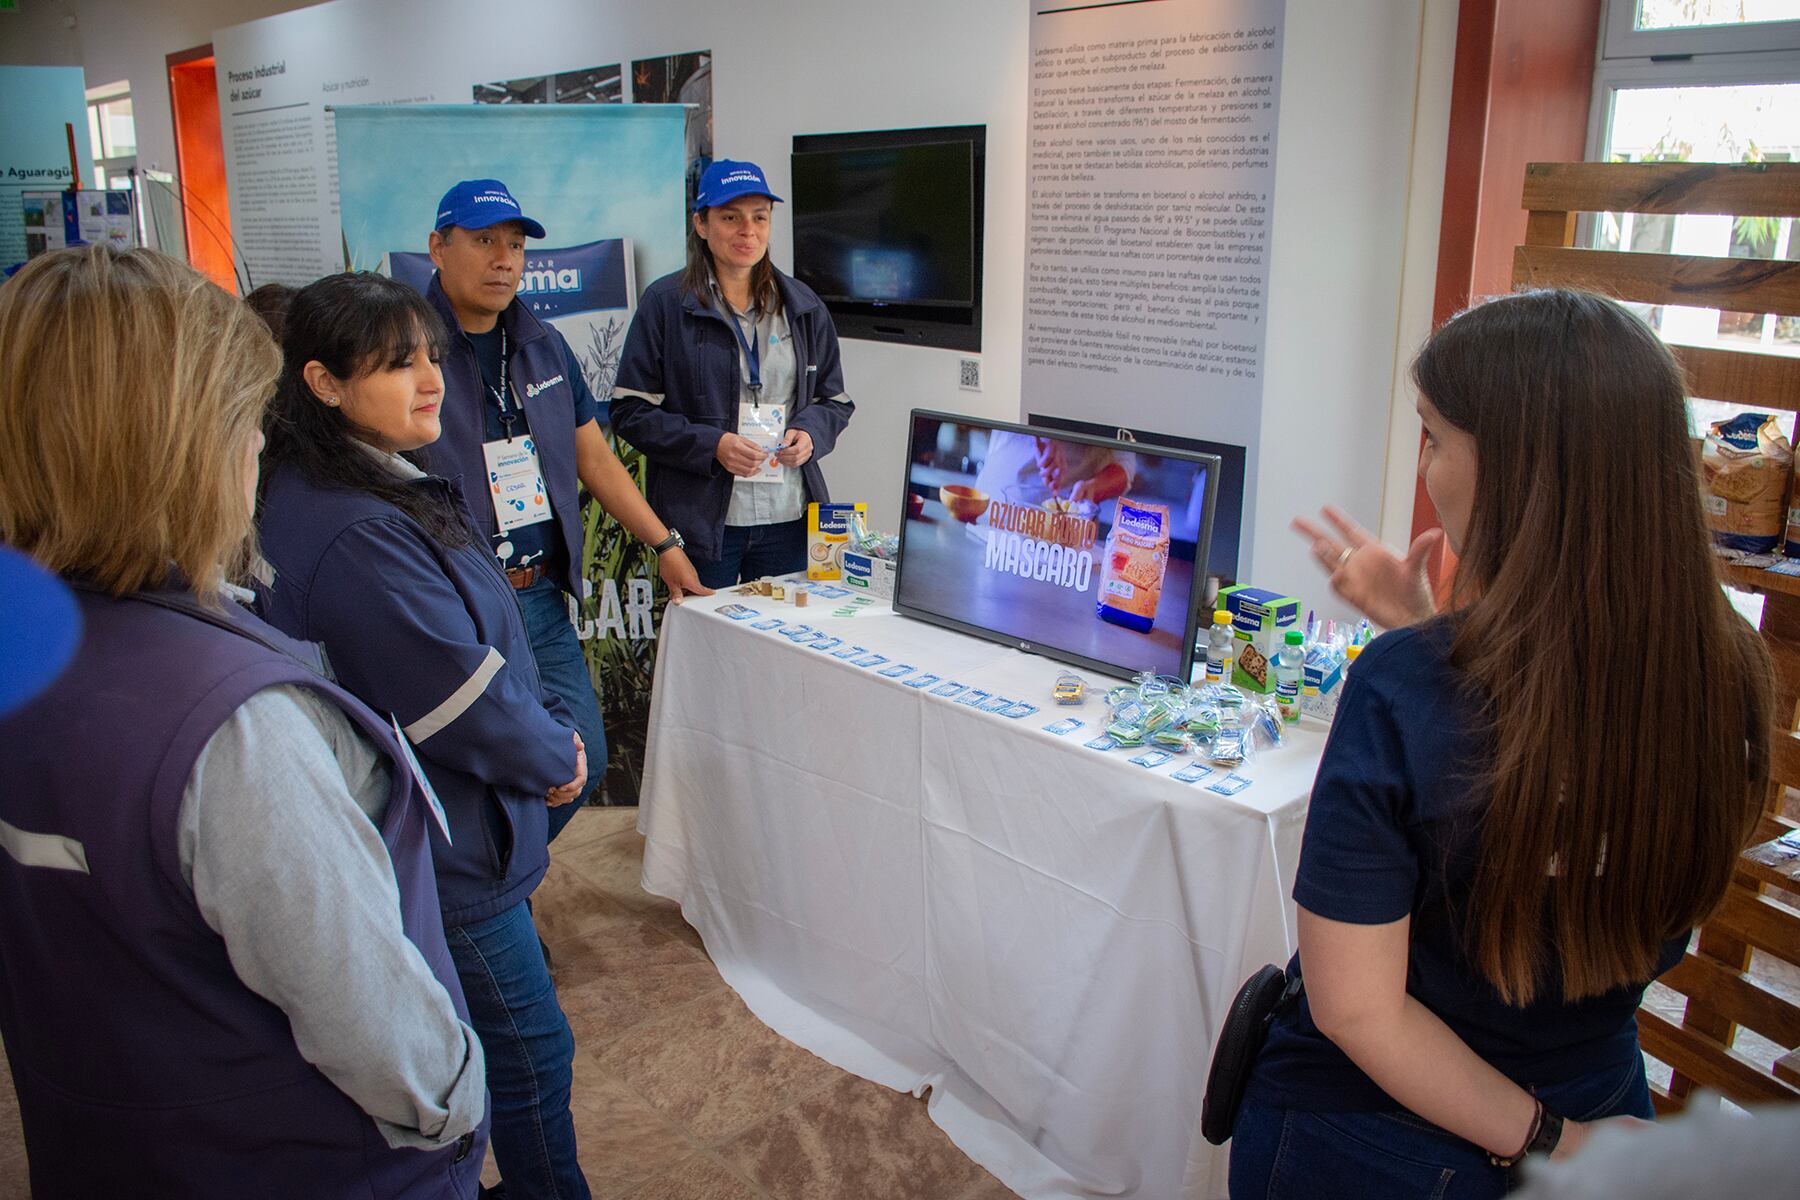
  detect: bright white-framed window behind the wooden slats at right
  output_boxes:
[1588,0,1800,385]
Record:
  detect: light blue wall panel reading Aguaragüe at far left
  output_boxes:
[0,67,94,266]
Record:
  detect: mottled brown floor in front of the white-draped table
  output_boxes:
[0,808,1013,1200]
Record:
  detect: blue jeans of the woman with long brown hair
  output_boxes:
[1231,1056,1654,1200]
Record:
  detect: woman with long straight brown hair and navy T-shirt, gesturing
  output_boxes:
[1231,291,1773,1198]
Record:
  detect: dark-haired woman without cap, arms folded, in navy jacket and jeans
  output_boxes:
[259,273,589,1200]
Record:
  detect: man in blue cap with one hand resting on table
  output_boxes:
[427,180,707,820]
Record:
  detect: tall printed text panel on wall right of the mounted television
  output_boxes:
[1021,0,1285,543]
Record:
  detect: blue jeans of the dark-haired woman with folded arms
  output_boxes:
[445,899,589,1200]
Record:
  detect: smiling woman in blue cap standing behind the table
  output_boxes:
[612,158,855,588]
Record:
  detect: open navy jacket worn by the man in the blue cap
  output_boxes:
[425,275,587,593]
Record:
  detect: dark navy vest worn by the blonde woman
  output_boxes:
[0,579,486,1200]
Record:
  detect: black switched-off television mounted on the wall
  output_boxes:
[790,126,986,351]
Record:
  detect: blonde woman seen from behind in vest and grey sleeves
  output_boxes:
[0,246,486,1200]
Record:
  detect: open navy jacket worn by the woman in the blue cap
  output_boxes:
[612,272,855,561]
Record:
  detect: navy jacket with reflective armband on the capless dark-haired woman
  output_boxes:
[257,466,574,925]
